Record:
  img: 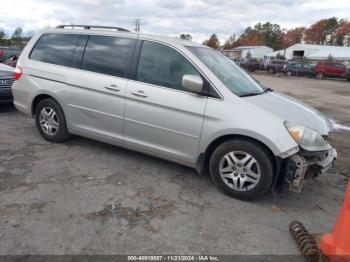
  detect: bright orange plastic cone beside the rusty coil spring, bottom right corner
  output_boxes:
[321,182,350,262]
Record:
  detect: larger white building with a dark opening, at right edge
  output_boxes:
[266,44,350,61]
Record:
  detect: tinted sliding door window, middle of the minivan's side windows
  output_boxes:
[81,36,135,77]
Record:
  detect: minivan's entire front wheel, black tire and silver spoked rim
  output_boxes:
[209,139,274,200]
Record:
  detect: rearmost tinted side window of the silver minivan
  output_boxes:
[29,34,79,66]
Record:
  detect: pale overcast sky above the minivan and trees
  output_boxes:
[0,0,350,42]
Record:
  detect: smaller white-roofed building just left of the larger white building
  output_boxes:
[221,46,273,58]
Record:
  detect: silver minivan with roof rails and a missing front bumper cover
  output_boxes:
[12,25,336,200]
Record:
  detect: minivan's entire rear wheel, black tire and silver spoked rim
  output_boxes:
[35,98,70,142]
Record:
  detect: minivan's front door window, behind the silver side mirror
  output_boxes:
[136,41,200,90]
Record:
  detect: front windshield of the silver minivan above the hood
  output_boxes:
[187,47,264,96]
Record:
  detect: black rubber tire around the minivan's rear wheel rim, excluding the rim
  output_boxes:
[35,98,70,143]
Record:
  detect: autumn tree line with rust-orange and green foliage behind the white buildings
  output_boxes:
[203,17,350,50]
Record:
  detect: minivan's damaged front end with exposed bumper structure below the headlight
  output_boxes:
[282,148,337,193]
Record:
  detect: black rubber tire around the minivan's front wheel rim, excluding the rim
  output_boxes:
[209,139,274,201]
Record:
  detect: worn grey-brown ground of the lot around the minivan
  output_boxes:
[0,75,350,255]
